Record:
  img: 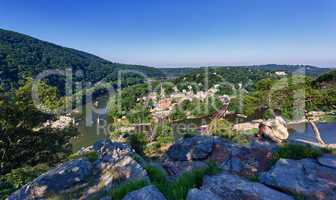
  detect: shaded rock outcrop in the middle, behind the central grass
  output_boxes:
[163,136,276,177]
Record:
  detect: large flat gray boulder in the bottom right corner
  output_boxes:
[260,159,336,200]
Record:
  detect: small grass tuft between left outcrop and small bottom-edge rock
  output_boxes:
[109,180,148,200]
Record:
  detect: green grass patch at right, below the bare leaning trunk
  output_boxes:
[271,144,324,164]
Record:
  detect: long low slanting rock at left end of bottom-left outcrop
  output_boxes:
[8,159,92,200]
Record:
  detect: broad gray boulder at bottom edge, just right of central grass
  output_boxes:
[187,173,293,200]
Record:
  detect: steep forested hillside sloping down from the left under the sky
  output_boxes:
[0,29,162,90]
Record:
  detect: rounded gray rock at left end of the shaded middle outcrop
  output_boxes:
[167,136,214,161]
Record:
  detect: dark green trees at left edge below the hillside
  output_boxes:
[0,79,78,199]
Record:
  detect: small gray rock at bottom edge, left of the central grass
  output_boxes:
[123,185,166,200]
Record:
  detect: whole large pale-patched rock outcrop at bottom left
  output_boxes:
[9,140,148,200]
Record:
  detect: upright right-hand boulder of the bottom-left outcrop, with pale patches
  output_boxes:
[80,140,149,199]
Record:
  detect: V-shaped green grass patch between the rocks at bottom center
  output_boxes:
[146,162,220,200]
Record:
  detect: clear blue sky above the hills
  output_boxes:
[0,0,336,67]
